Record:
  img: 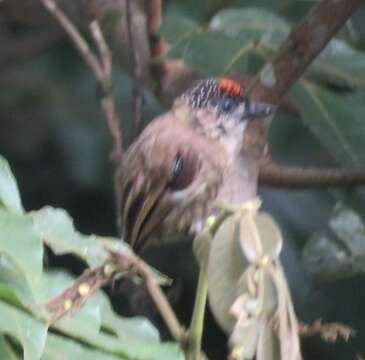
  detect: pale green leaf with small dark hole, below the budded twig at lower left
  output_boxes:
[35,271,181,360]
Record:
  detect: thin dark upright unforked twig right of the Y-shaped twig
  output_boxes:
[126,0,144,137]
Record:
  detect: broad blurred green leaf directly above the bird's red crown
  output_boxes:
[167,8,289,76]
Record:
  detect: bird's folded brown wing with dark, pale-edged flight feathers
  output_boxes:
[116,115,210,252]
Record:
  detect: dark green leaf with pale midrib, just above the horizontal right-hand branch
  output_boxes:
[293,80,365,166]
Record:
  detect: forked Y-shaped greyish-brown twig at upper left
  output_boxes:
[40,0,123,163]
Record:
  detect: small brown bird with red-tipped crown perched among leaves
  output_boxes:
[115,78,275,253]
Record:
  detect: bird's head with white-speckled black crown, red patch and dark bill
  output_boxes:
[174,78,275,152]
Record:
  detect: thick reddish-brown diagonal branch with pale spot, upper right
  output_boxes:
[250,0,362,104]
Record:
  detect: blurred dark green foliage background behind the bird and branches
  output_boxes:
[0,0,365,359]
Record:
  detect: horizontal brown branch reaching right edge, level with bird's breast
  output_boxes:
[259,163,365,189]
